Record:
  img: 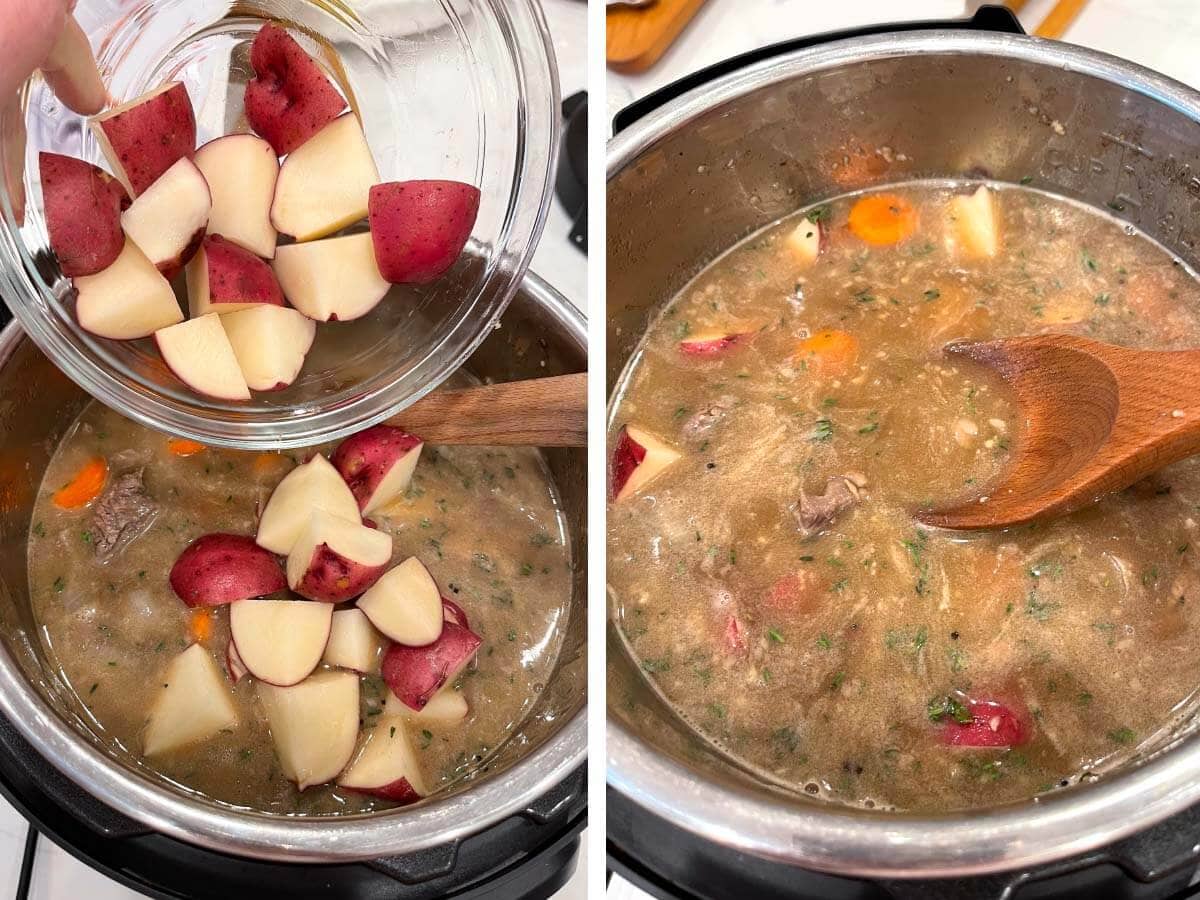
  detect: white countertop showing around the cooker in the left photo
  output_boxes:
[0,0,587,900]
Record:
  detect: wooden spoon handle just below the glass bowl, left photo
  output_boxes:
[388,372,588,446]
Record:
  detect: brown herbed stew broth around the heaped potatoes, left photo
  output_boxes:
[29,403,571,815]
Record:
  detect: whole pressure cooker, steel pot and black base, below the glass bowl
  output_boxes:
[0,275,587,900]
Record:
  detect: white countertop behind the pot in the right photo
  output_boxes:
[607,0,1200,900]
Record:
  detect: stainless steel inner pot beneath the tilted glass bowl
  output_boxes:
[0,275,587,863]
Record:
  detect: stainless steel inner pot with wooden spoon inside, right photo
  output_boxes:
[606,30,1200,877]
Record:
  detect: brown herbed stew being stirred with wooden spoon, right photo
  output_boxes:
[608,182,1200,811]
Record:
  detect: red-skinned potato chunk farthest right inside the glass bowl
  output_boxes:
[367,181,480,284]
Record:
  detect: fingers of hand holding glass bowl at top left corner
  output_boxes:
[0,0,108,115]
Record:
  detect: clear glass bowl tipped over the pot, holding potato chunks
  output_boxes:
[0,0,558,449]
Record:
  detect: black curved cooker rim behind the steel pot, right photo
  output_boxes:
[613,6,1025,134]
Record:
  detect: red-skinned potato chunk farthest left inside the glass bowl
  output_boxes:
[37,152,130,278]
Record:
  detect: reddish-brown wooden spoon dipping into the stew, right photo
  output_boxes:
[917,335,1200,529]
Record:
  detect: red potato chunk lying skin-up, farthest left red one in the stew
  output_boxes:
[170,533,288,606]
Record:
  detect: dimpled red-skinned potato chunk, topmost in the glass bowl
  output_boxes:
[245,24,346,156]
